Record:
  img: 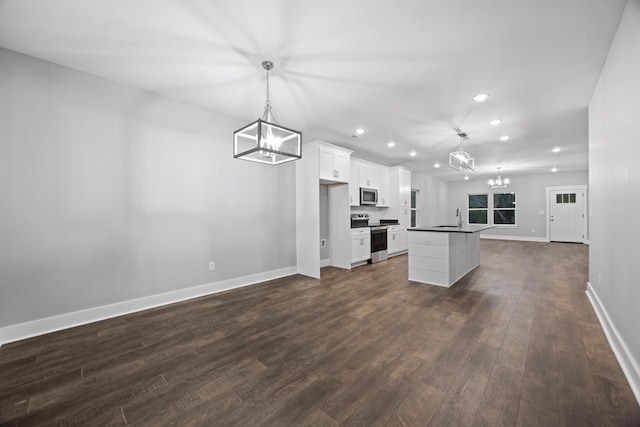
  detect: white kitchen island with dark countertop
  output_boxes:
[407,224,494,288]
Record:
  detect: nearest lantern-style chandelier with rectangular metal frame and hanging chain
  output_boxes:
[233,61,302,165]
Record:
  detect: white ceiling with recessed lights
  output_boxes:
[0,0,626,180]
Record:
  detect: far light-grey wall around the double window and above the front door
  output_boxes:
[447,171,588,240]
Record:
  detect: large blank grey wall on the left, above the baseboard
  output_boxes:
[0,50,296,343]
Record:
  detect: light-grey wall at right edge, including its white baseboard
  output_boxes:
[589,0,640,401]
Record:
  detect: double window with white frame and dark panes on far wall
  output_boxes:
[468,193,516,226]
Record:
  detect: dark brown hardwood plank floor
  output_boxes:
[0,240,640,426]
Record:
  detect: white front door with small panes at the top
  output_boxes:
[549,189,585,243]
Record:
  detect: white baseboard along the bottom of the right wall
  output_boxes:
[587,282,640,404]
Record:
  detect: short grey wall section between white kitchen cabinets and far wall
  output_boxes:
[411,172,449,227]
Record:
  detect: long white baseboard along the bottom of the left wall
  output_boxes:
[0,266,297,346]
